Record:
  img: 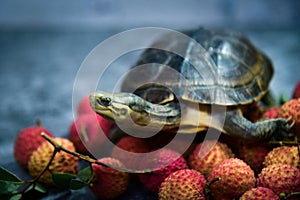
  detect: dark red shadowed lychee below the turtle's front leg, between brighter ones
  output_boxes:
[238,142,270,172]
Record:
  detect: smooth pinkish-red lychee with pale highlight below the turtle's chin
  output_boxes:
[69,114,111,153]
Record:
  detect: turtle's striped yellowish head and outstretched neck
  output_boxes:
[90,91,180,126]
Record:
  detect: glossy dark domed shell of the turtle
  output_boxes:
[122,28,273,106]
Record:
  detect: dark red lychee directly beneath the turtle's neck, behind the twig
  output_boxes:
[111,136,150,171]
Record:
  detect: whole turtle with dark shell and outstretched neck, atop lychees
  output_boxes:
[90,28,292,140]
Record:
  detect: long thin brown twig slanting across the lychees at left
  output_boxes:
[41,132,152,173]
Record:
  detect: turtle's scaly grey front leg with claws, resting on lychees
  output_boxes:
[223,109,292,140]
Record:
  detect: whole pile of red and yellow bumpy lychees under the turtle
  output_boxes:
[14,82,300,200]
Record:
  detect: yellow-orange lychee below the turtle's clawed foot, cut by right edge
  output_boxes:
[264,146,300,167]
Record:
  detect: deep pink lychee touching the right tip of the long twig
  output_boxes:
[139,149,188,193]
